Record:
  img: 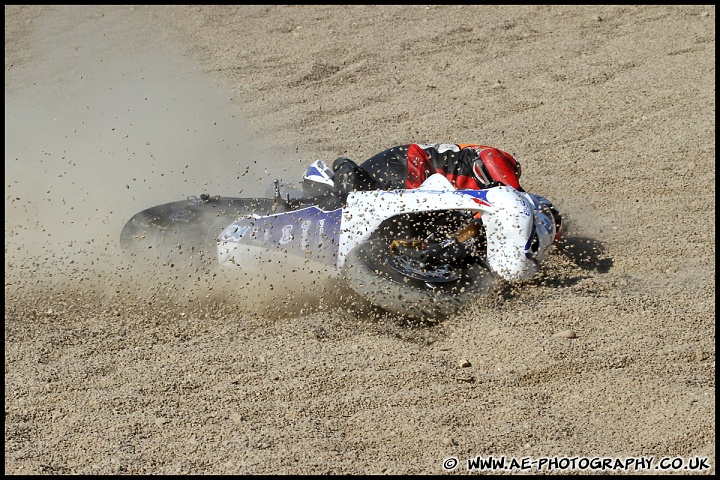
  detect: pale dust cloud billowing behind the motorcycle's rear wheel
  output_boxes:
[5,6,320,316]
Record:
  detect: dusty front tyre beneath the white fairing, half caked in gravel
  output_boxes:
[342,237,496,320]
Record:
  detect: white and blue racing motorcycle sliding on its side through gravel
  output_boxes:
[120,162,561,319]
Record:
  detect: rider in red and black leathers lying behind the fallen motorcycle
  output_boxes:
[303,143,562,262]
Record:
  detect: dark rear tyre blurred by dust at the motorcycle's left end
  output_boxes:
[120,197,277,267]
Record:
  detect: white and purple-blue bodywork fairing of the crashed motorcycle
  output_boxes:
[218,174,555,281]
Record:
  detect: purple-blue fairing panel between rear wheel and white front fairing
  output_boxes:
[220,207,342,264]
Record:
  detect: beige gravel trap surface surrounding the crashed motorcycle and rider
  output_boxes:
[5,5,715,474]
